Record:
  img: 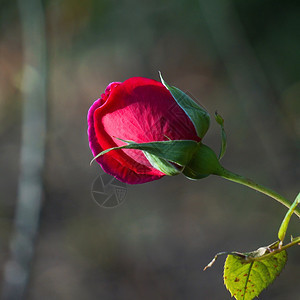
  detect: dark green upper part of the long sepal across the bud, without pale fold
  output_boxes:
[92,139,198,166]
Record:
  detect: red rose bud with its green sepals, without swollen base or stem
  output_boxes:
[88,77,205,184]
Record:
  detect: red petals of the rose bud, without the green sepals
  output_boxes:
[88,77,207,184]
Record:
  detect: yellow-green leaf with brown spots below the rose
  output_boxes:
[224,248,287,300]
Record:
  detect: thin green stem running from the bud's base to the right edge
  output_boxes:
[218,168,300,218]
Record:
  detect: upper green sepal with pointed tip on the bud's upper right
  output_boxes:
[159,72,210,138]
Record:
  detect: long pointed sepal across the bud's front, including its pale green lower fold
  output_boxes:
[92,139,198,176]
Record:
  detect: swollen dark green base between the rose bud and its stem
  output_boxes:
[182,143,223,179]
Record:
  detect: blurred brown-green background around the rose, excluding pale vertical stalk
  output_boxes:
[0,0,300,300]
